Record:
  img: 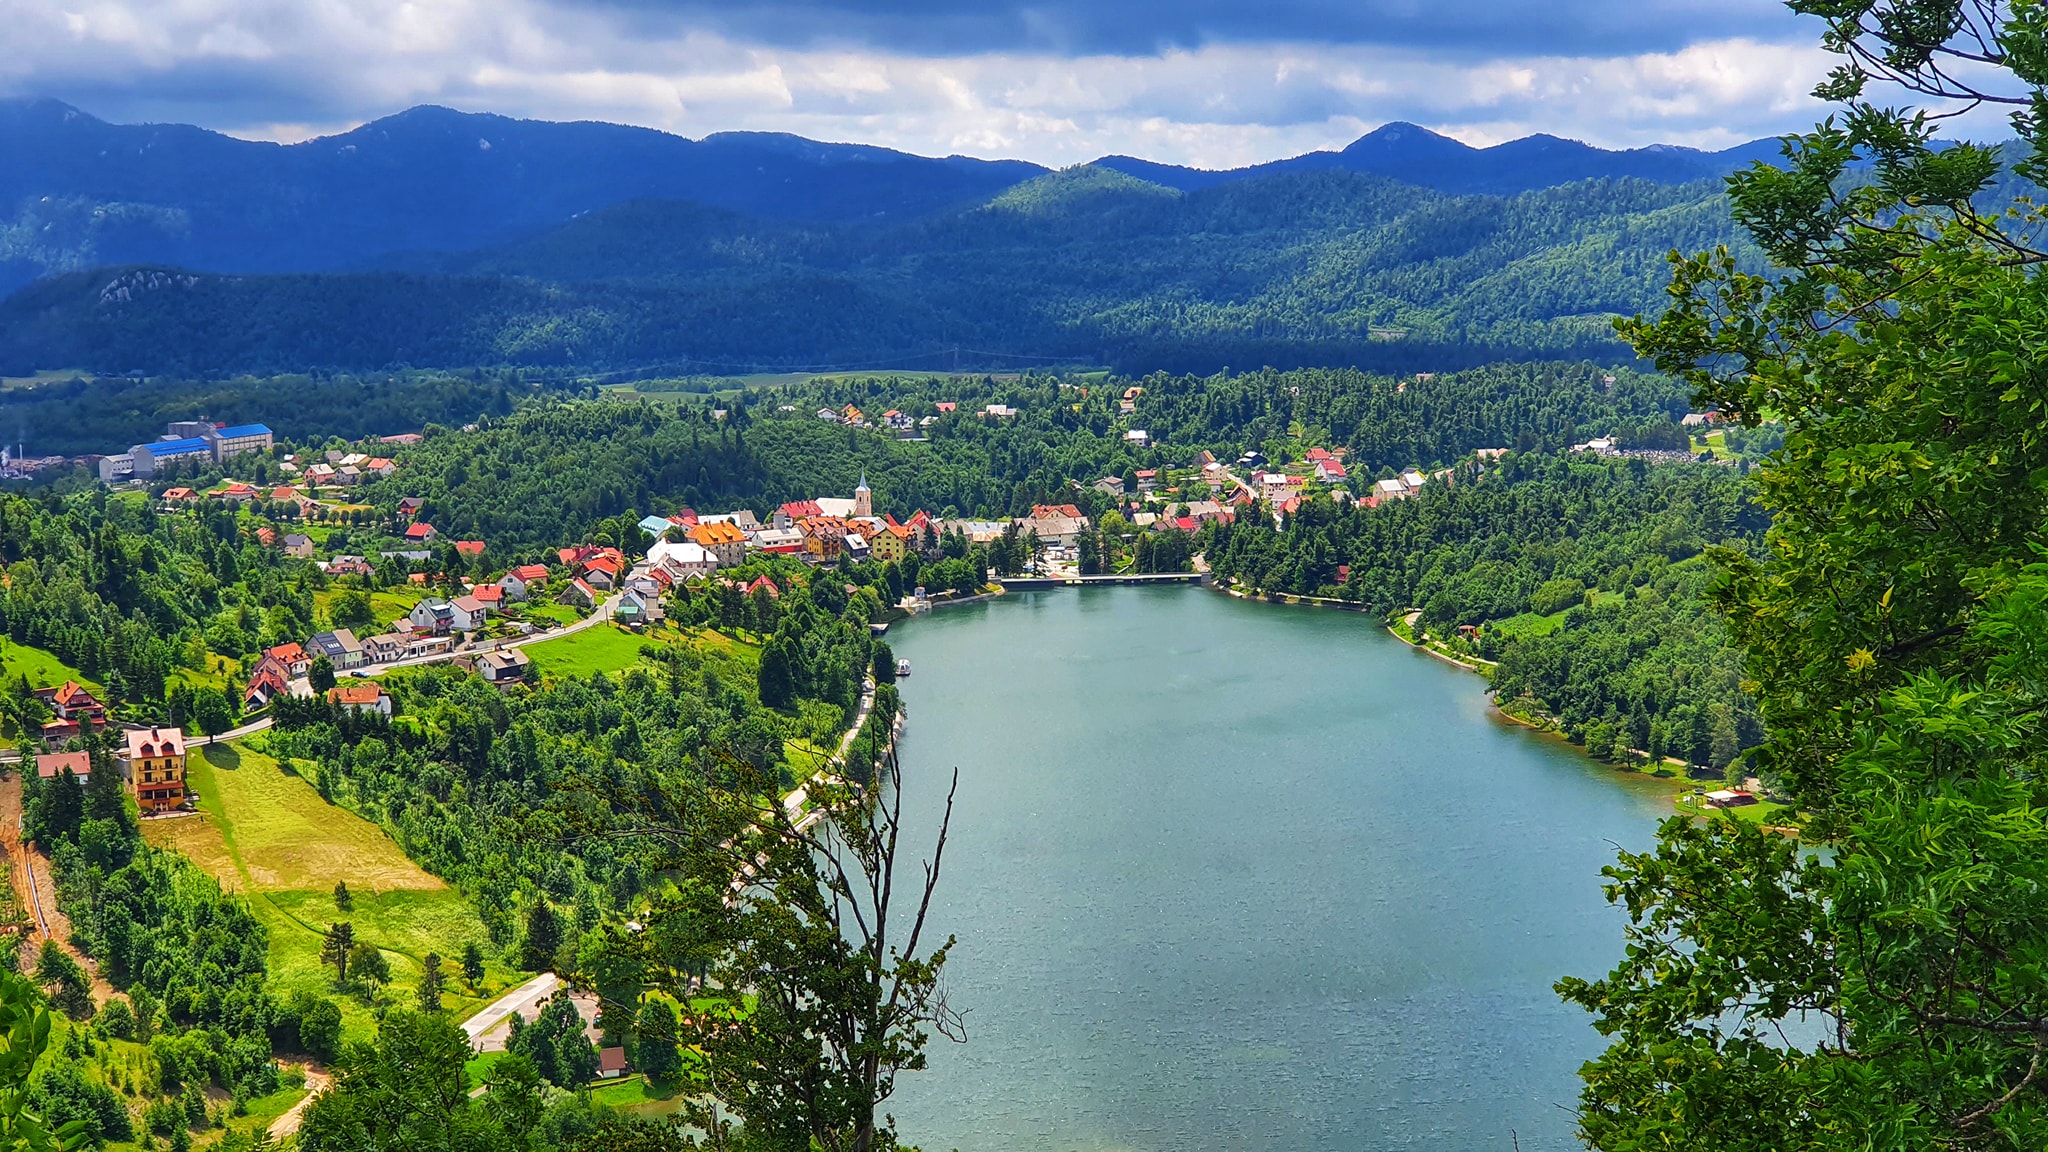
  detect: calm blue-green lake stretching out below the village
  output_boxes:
[889,586,1671,1152]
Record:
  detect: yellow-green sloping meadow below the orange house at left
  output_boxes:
[143,744,520,1035]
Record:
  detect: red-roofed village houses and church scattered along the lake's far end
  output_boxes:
[35,387,1531,814]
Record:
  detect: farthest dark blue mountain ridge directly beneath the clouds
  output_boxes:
[0,98,1776,295]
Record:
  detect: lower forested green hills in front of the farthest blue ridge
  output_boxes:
[0,166,1741,375]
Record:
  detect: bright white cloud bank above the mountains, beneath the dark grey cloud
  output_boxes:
[0,0,1829,166]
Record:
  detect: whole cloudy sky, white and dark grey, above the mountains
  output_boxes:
[0,0,1829,168]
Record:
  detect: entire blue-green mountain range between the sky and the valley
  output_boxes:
[0,100,1776,375]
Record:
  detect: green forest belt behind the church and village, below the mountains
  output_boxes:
[365,363,1686,553]
